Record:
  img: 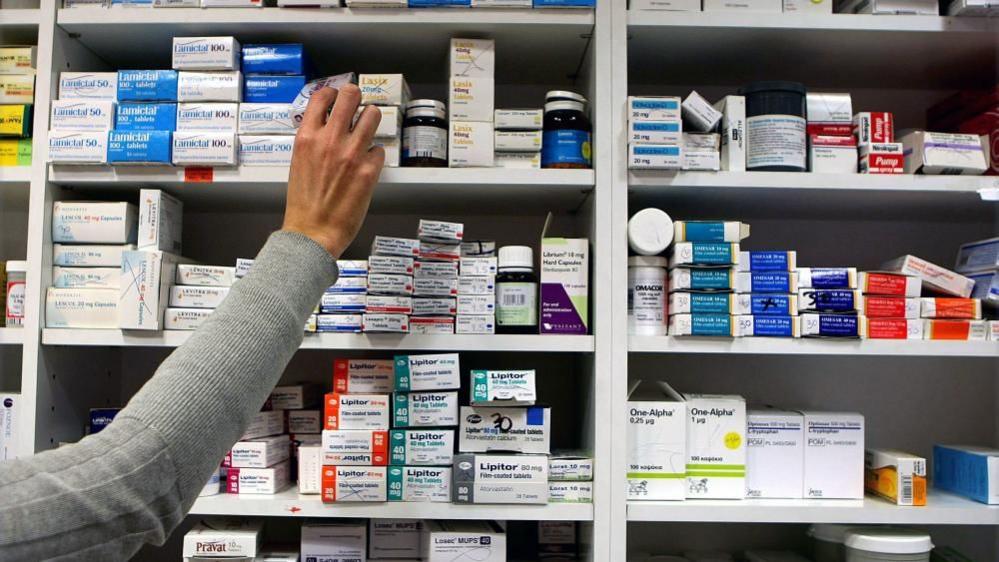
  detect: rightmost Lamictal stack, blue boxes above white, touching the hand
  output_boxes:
[239,43,307,166]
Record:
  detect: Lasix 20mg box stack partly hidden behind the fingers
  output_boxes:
[358,74,410,168]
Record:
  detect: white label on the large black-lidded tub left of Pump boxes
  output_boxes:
[746,115,808,170]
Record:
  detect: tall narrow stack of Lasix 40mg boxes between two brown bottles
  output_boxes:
[448,39,496,168]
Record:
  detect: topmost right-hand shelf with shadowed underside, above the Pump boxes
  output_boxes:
[628,11,999,89]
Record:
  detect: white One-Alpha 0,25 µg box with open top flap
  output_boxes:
[627,381,687,500]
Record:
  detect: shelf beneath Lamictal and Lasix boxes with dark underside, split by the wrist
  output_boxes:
[49,166,595,214]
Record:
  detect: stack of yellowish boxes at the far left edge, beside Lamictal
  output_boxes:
[0,46,38,166]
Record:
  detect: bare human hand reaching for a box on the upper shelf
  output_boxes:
[282,84,385,258]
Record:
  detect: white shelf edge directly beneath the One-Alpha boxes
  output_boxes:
[628,491,999,525]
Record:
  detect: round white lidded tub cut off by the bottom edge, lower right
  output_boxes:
[844,527,933,562]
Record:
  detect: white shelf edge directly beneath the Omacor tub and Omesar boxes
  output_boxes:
[628,336,999,359]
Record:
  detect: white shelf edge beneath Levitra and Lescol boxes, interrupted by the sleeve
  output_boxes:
[42,328,594,353]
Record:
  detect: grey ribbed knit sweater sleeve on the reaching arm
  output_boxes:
[0,232,337,561]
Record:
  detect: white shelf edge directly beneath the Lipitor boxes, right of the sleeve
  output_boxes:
[190,489,593,521]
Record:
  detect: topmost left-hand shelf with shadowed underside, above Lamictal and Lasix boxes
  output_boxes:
[58,8,594,84]
